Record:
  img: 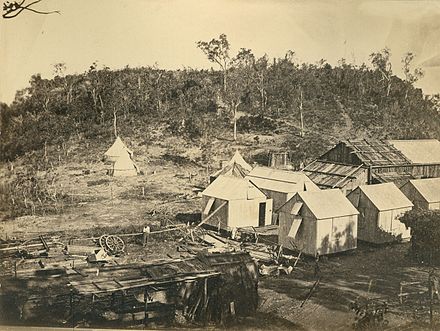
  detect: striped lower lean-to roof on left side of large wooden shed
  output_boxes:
[303,160,366,188]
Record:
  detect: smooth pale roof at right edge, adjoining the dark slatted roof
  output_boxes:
[388,139,440,164]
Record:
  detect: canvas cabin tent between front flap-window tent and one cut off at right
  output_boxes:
[347,183,413,244]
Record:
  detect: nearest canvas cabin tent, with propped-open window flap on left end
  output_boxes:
[278,189,359,256]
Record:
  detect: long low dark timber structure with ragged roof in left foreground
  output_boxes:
[2,252,258,327]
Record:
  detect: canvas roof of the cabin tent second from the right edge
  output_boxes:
[359,183,413,211]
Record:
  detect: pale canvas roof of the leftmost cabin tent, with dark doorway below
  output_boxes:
[202,176,266,201]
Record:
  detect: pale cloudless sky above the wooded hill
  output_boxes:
[0,0,440,103]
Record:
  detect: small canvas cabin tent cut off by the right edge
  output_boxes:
[400,178,440,210]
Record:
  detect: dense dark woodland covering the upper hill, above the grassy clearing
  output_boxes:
[0,35,440,165]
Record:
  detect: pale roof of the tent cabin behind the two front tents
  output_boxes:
[246,167,319,193]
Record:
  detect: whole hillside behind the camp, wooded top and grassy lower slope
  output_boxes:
[0,50,440,223]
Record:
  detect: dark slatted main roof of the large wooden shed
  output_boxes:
[342,139,410,166]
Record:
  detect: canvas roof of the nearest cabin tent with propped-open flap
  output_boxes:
[297,189,359,219]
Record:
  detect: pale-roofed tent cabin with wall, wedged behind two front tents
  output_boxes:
[246,167,319,211]
